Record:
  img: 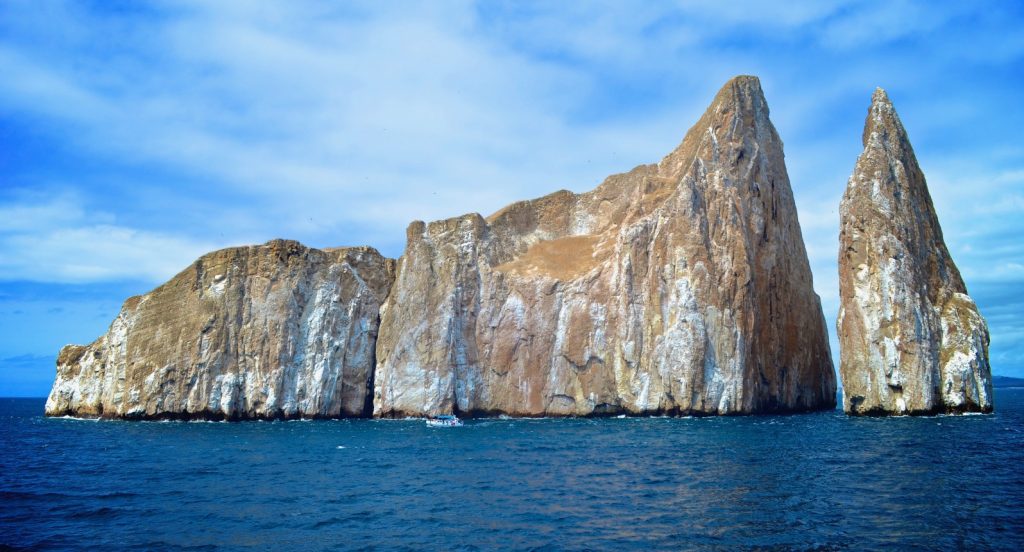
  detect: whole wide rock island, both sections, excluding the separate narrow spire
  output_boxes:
[46,77,836,419]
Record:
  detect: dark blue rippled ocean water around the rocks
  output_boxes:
[0,389,1024,550]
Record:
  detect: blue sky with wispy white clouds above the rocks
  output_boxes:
[0,0,1024,396]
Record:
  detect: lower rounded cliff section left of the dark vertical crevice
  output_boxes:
[46,240,394,419]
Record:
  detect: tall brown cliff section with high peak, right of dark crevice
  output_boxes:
[374,77,836,417]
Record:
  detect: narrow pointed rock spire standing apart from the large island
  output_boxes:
[837,88,992,415]
